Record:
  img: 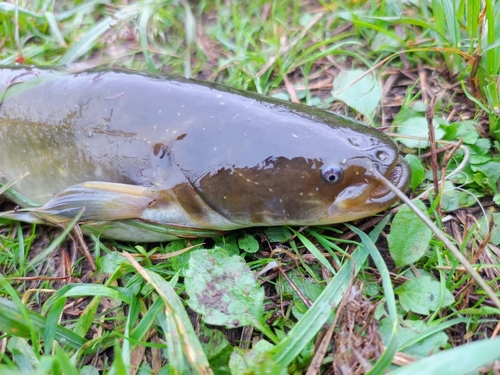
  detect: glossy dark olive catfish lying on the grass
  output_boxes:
[0,68,409,241]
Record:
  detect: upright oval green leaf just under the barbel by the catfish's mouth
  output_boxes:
[387,200,432,267]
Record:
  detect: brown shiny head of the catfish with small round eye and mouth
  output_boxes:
[188,123,410,226]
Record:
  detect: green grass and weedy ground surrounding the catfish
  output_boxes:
[0,0,500,375]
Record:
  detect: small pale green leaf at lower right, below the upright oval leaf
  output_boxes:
[395,275,455,315]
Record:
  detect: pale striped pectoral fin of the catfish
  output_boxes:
[31,181,155,222]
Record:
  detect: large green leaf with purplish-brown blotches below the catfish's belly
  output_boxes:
[185,249,264,328]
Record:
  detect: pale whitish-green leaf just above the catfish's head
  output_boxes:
[332,69,382,120]
